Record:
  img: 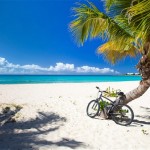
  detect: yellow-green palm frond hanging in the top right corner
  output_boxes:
[127,0,150,43]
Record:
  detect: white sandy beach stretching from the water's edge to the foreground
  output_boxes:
[0,82,150,150]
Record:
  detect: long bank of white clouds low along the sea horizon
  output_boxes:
[0,57,119,74]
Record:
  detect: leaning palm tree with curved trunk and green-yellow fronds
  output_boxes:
[70,0,150,104]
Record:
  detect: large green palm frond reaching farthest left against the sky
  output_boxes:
[70,3,132,44]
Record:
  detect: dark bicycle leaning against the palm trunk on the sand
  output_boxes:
[86,87,134,126]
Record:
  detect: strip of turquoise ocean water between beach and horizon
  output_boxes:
[0,75,141,84]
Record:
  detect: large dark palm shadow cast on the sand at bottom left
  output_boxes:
[0,108,85,149]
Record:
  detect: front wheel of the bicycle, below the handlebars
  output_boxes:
[86,100,100,118]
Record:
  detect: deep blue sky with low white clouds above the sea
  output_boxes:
[0,0,139,74]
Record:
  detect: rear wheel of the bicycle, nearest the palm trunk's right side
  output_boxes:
[111,104,134,126]
